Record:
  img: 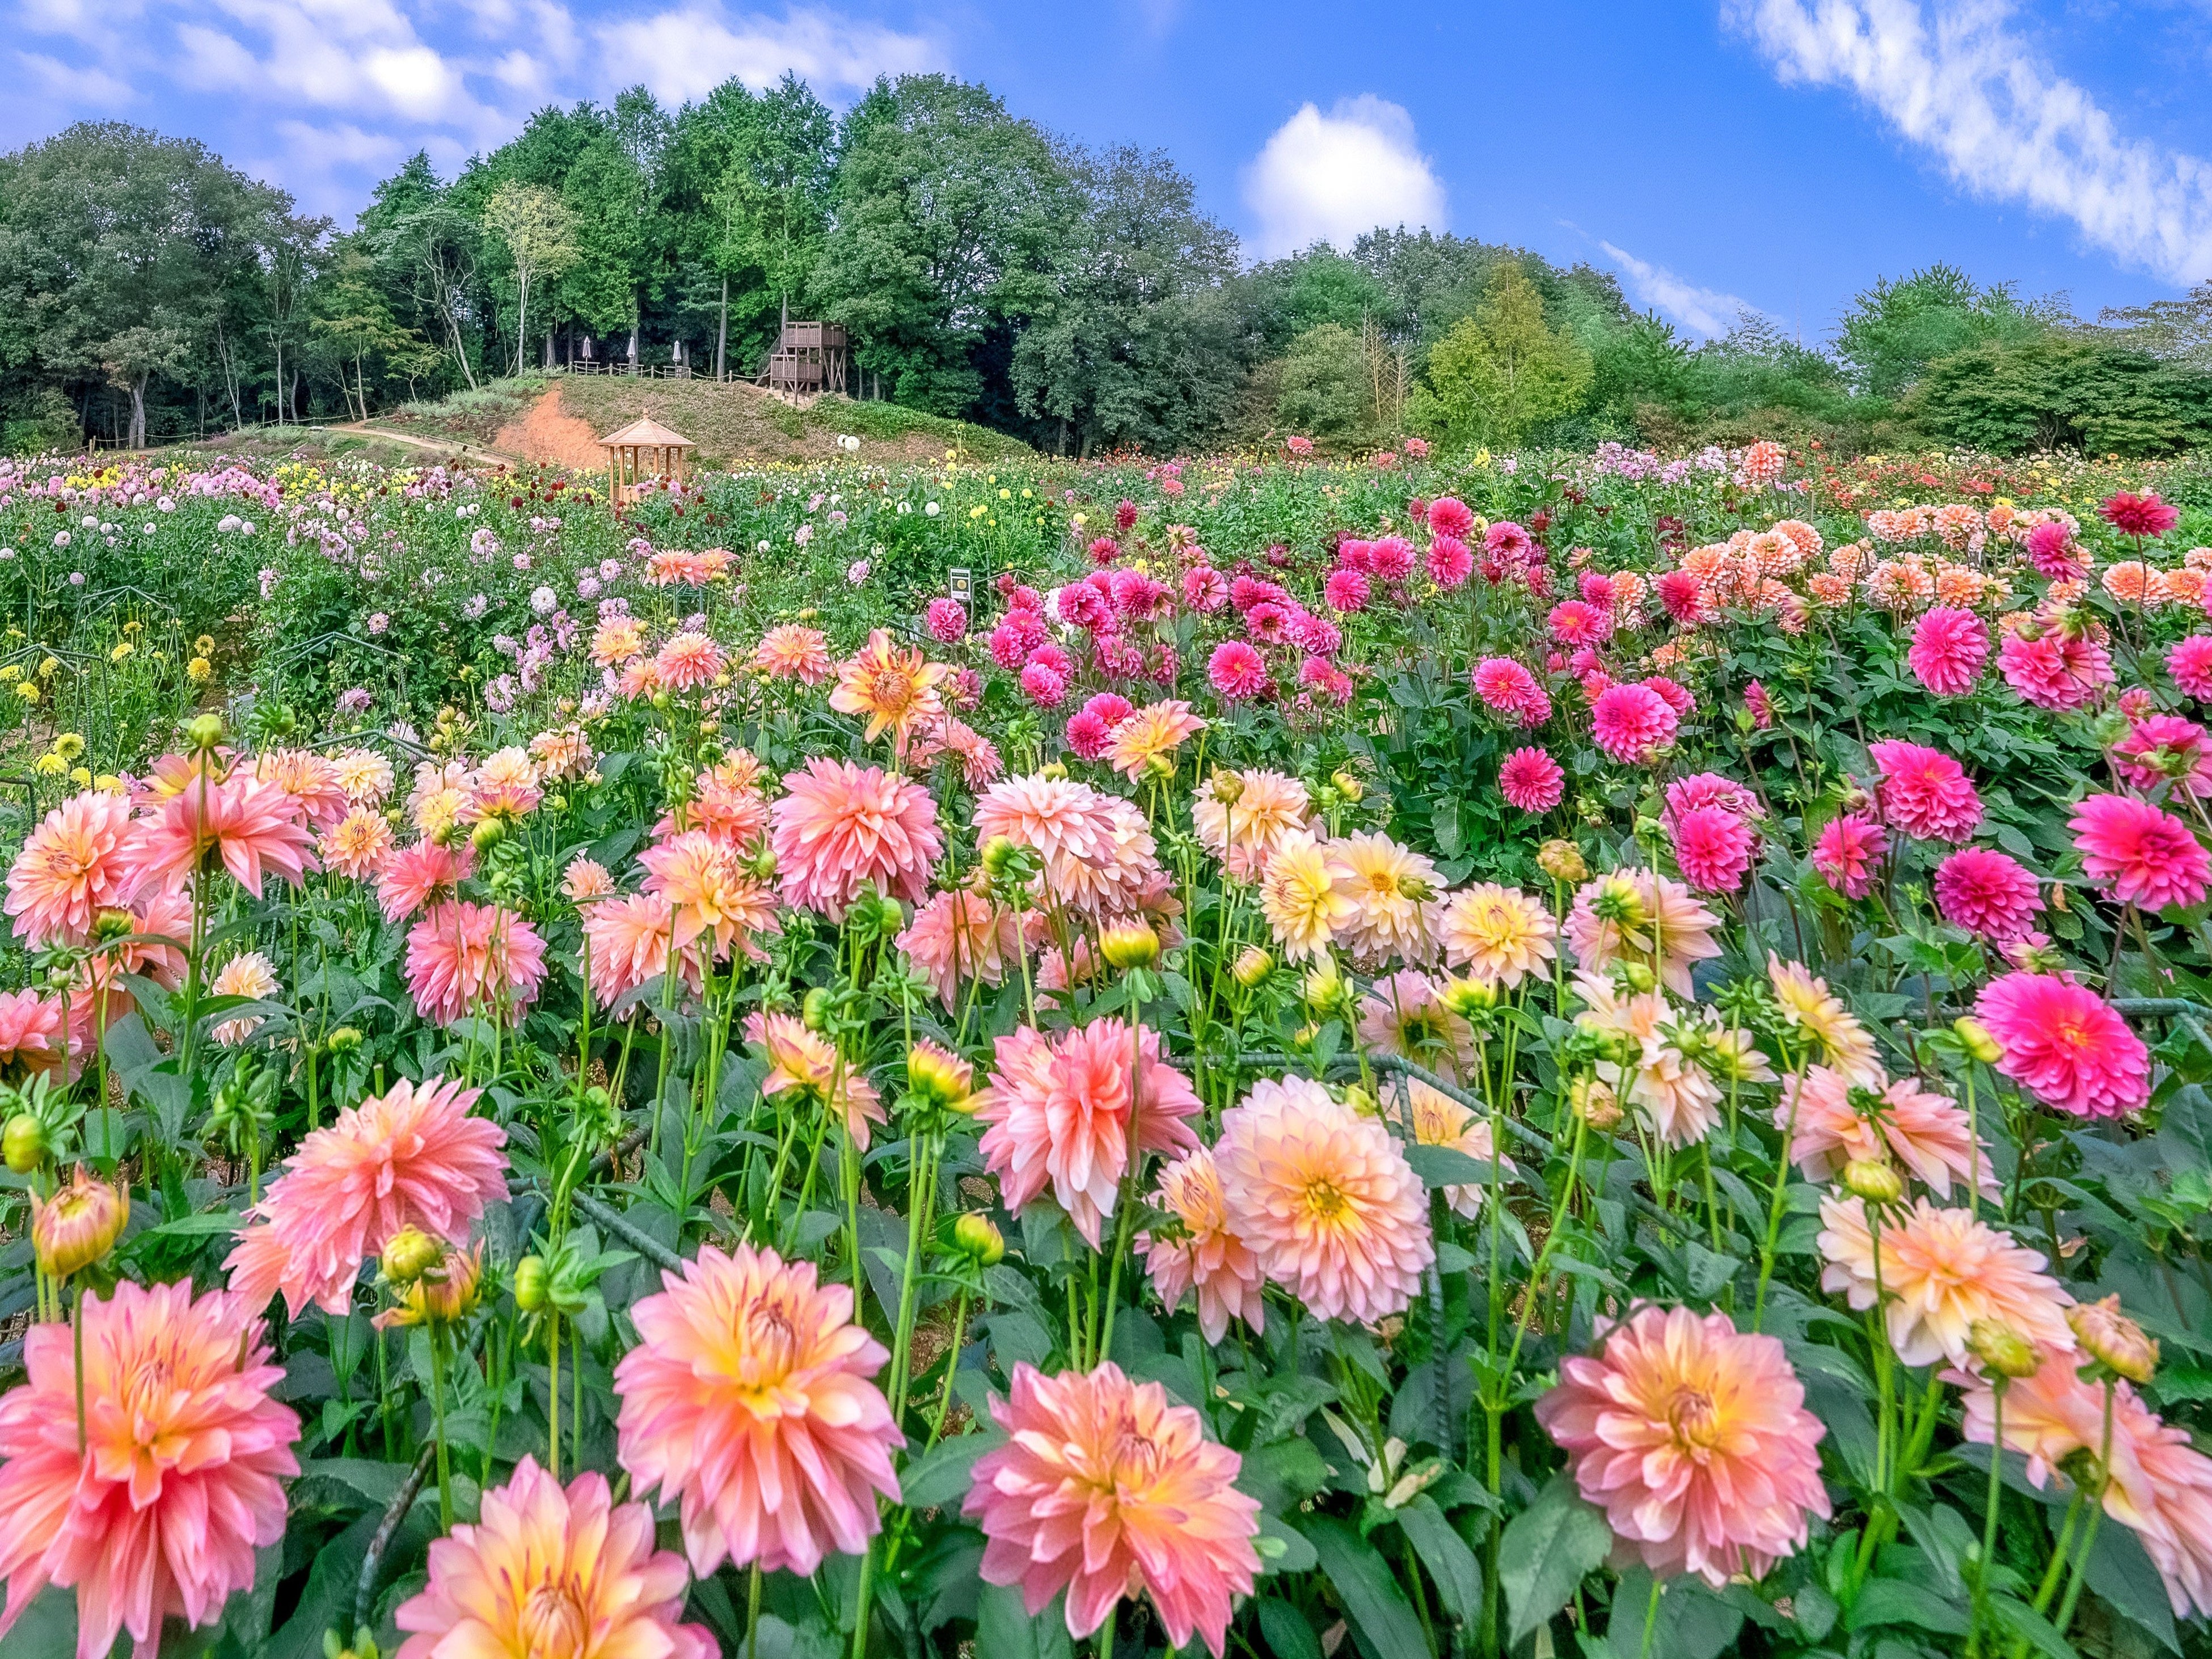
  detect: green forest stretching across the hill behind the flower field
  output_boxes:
[12,75,2212,455]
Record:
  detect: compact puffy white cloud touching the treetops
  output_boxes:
[1243,93,1445,259]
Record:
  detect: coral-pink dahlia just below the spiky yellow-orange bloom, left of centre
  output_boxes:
[770,757,944,922]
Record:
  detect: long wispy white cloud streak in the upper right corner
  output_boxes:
[1728,0,2212,283]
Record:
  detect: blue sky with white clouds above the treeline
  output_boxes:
[12,0,2212,343]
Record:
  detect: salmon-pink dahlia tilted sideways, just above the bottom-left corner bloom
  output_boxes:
[223,1077,506,1318]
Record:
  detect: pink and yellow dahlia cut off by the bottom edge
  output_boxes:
[391,1455,717,1659]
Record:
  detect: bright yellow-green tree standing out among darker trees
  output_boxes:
[1422,263,1593,445]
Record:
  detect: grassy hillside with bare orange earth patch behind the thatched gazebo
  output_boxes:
[376,374,1029,467]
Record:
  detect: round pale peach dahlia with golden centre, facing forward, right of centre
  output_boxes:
[1214,1077,1436,1325]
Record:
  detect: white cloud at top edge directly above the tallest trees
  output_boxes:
[593,0,947,104]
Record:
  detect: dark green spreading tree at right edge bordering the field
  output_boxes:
[1905,330,2212,455]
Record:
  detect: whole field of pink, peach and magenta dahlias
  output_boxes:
[0,440,2212,1659]
